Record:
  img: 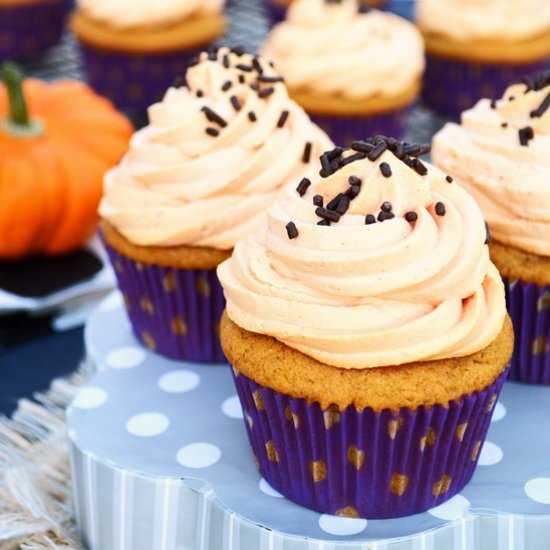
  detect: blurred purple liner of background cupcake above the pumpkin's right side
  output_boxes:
[80,42,202,113]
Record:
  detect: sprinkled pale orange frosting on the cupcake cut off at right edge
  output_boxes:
[433,73,550,256]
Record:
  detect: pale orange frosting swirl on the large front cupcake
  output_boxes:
[218,139,506,369]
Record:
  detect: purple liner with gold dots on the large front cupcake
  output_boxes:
[234,370,506,519]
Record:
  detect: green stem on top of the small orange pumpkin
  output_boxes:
[0,61,43,137]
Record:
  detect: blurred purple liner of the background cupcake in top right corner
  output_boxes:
[422,54,548,120]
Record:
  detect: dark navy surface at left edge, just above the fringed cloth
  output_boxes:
[0,326,84,415]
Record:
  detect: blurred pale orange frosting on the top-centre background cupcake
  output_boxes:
[262,0,424,100]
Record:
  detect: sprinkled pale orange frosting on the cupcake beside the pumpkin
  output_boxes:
[100,48,332,250]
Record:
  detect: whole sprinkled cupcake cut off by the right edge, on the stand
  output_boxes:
[433,73,550,384]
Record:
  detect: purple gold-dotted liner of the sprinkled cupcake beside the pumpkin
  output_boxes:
[101,239,226,363]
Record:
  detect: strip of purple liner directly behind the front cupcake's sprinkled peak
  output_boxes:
[309,107,410,144]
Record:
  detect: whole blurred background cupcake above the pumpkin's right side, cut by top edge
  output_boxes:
[71,0,229,112]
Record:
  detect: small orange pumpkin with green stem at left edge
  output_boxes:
[0,62,132,259]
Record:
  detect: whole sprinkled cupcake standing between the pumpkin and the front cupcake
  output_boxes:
[100,48,330,362]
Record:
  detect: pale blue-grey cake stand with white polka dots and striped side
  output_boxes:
[67,293,550,550]
